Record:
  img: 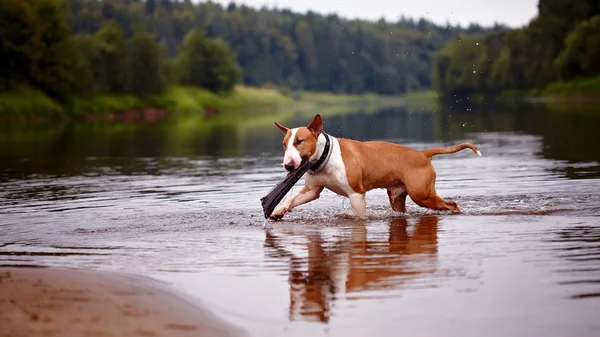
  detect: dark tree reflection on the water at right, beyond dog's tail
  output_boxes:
[435,103,600,173]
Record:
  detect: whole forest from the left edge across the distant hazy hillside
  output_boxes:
[0,0,506,113]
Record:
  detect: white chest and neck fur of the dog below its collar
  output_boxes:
[306,135,354,197]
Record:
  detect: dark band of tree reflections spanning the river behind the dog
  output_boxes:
[0,102,600,177]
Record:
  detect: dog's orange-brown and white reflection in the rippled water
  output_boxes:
[265,215,438,322]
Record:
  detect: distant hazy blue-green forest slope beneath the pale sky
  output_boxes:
[68,0,505,94]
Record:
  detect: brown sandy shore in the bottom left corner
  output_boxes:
[0,268,246,337]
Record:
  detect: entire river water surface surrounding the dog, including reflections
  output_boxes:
[0,103,600,337]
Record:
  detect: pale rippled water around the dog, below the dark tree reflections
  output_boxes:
[0,134,600,336]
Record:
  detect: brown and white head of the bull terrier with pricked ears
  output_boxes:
[275,114,323,172]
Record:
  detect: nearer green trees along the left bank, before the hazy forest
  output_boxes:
[0,0,241,102]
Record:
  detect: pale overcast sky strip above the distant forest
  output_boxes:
[207,0,538,27]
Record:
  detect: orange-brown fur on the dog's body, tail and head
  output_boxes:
[273,115,479,218]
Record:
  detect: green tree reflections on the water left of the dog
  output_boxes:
[0,120,241,177]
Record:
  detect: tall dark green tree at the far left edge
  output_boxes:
[0,0,77,100]
